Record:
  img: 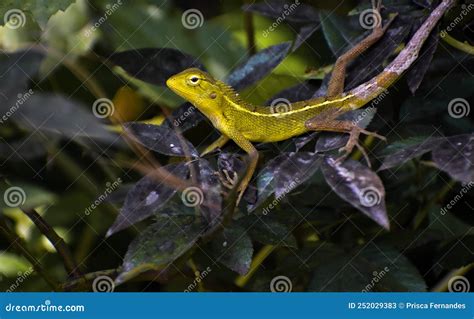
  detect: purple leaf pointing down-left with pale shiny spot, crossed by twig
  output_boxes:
[107,163,188,237]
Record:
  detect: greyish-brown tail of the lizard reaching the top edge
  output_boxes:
[349,0,455,109]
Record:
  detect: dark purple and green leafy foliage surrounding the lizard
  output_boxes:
[0,0,474,291]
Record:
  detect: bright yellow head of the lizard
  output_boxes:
[166,68,222,114]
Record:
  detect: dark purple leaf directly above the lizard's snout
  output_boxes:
[109,48,204,85]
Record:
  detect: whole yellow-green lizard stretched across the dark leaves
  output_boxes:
[166,0,454,204]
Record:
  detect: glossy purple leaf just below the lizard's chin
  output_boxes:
[125,122,199,157]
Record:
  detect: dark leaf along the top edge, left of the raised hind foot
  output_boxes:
[242,0,319,23]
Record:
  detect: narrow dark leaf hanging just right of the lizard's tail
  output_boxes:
[406,26,439,94]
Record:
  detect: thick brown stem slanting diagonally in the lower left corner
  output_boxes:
[22,209,81,277]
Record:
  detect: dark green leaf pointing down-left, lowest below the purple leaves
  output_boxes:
[116,216,201,283]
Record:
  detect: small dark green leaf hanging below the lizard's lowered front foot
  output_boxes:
[211,225,253,275]
